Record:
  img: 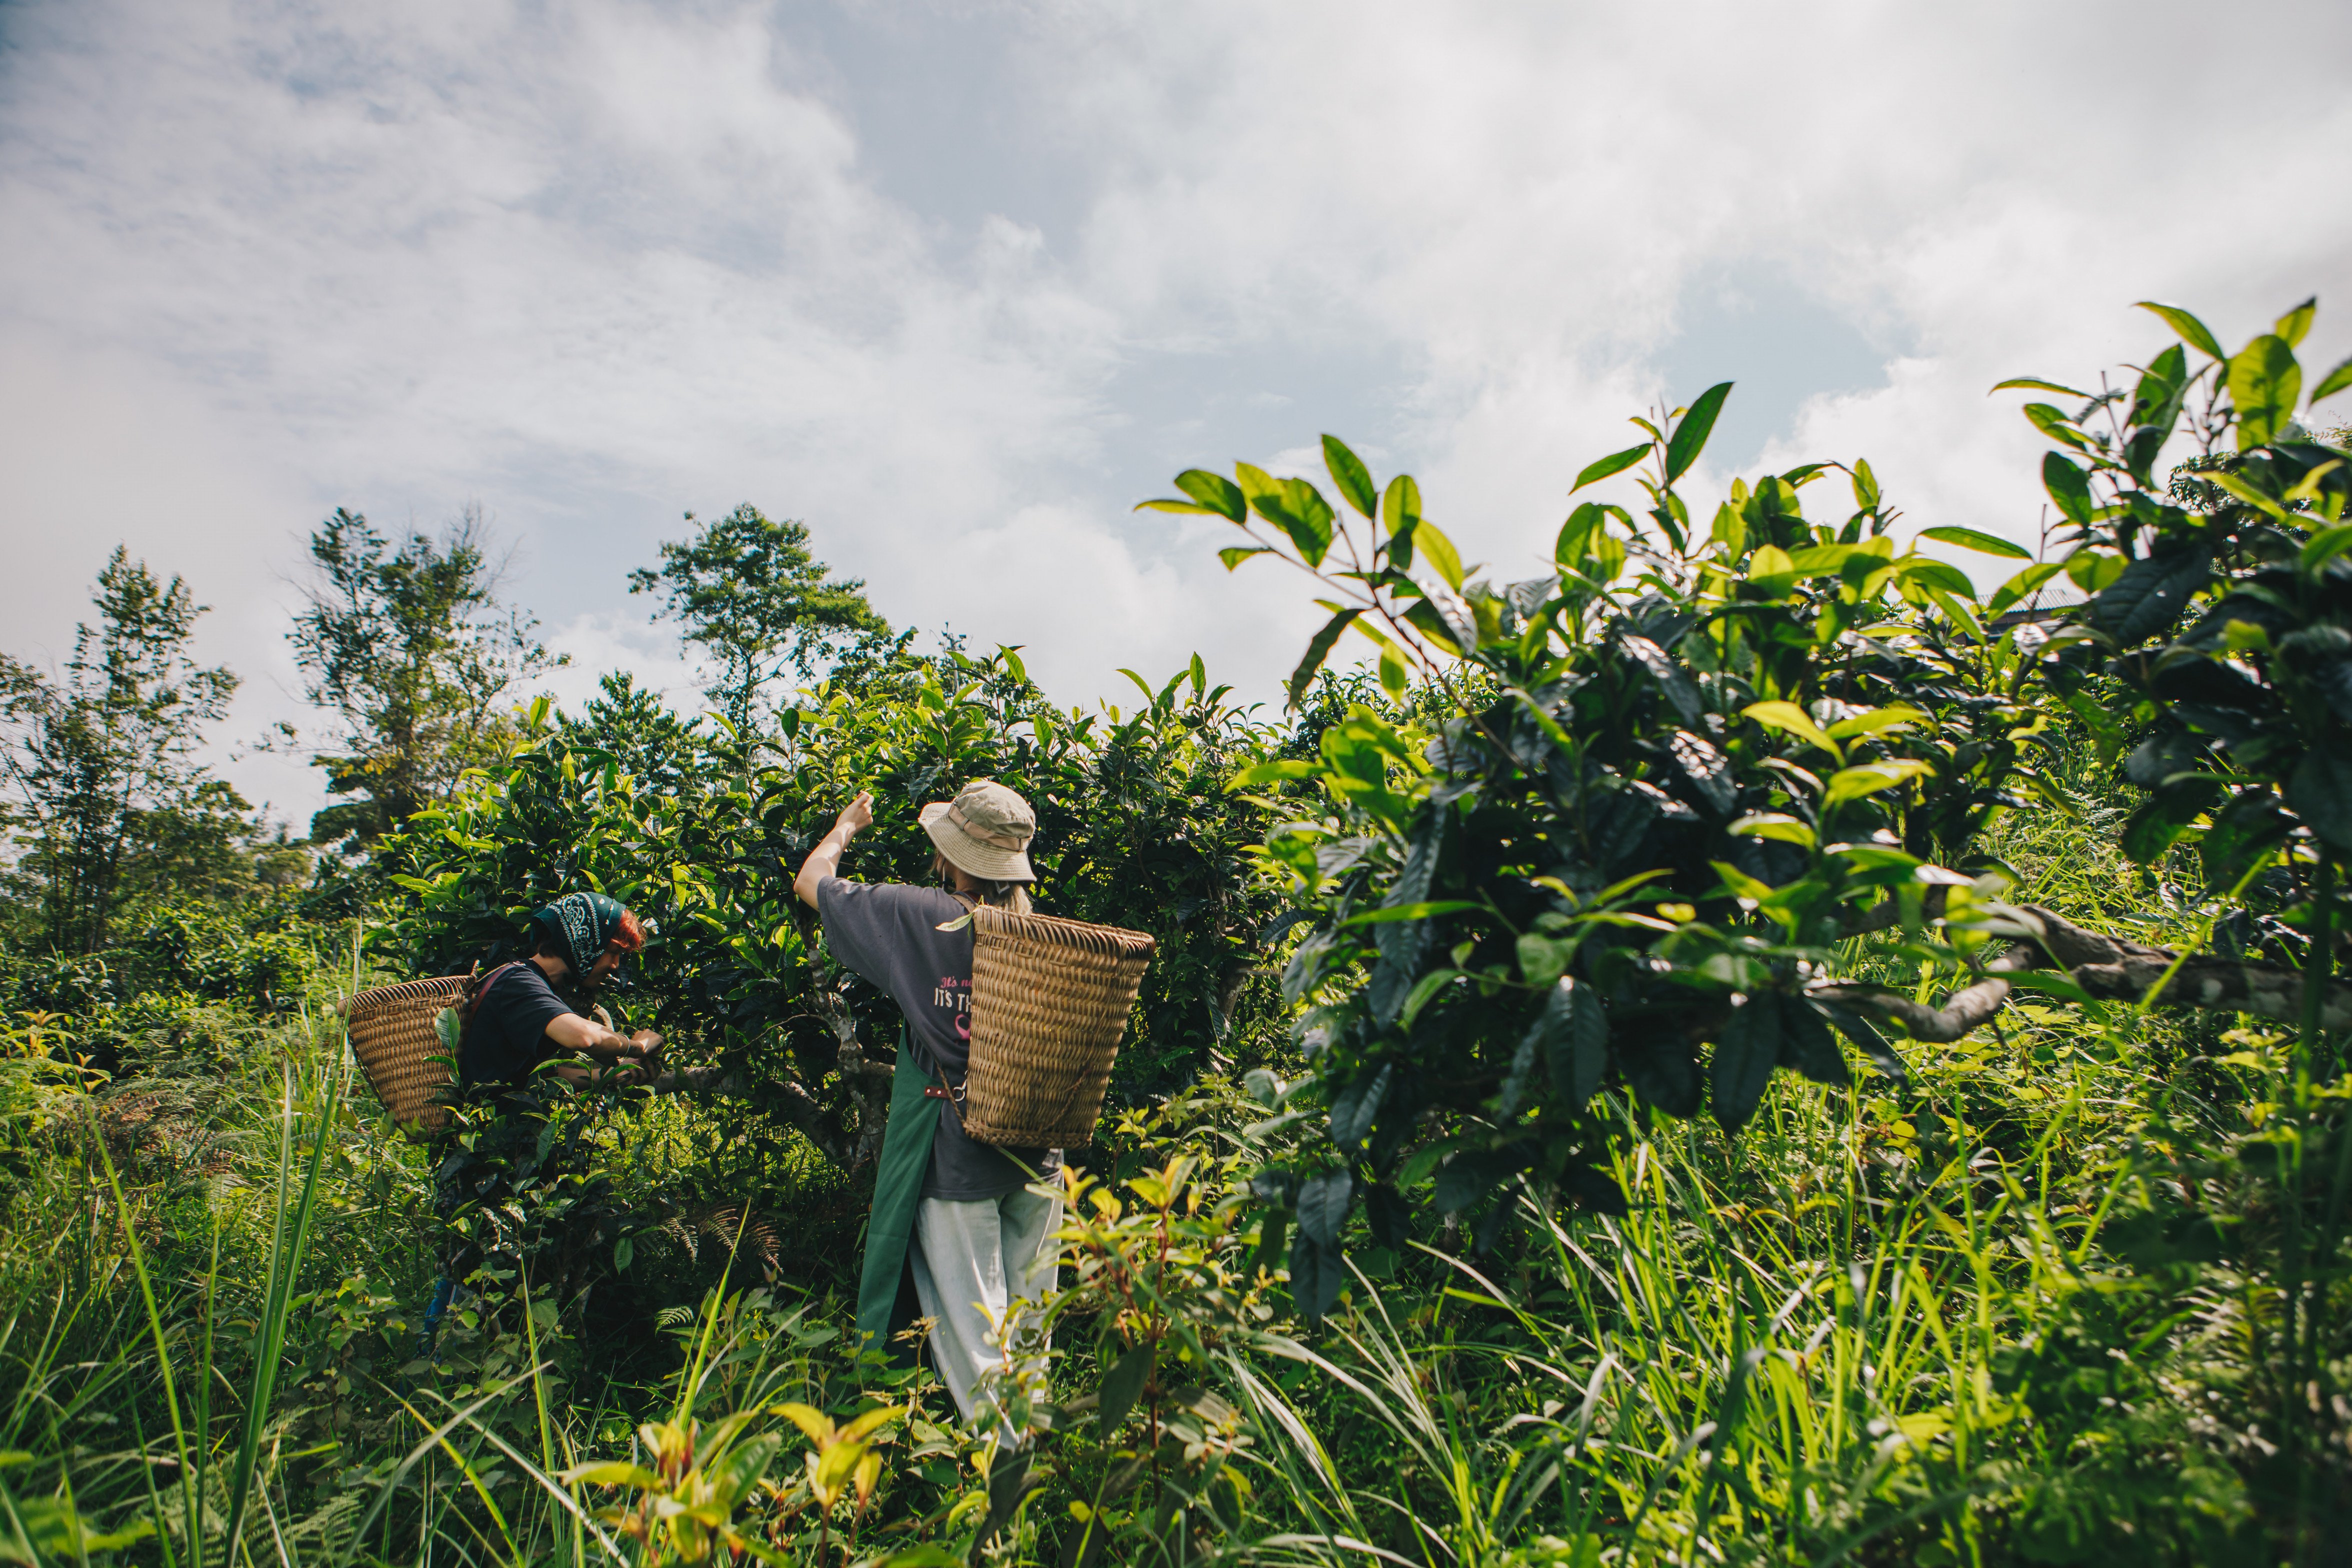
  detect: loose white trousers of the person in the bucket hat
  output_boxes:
[908,1190,1061,1422]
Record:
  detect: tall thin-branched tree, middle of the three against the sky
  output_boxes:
[290,508,567,846]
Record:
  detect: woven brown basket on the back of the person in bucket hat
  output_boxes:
[964,902,1155,1150]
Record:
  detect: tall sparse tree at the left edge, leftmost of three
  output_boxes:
[0,546,247,952]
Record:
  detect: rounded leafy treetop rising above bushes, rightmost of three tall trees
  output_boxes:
[628,500,889,729]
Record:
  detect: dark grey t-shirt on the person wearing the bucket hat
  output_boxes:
[816,877,1061,1204]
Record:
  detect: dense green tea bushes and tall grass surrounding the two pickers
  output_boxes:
[0,297,2352,1568]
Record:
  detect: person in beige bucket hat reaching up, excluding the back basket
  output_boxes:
[792,778,1061,1434]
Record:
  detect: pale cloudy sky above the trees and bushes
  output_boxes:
[0,0,2352,825]
